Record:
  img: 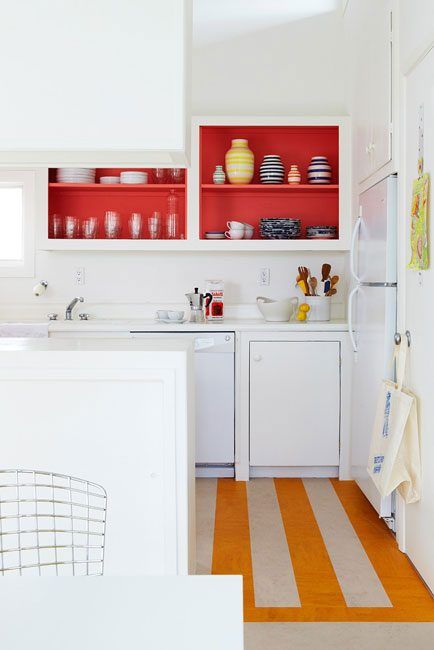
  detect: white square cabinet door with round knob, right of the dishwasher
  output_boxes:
[250,341,340,466]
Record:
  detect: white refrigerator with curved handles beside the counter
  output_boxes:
[348,176,397,517]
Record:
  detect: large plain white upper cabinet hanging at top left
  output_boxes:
[0,0,191,164]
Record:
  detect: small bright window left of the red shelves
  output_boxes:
[0,170,35,277]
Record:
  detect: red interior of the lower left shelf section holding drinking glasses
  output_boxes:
[48,168,187,239]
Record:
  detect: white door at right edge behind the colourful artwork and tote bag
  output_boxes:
[402,49,434,591]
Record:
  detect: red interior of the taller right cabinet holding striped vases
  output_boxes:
[199,126,339,238]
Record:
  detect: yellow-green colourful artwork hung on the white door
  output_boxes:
[408,174,429,271]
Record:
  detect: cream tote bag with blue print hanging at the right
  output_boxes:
[367,343,421,503]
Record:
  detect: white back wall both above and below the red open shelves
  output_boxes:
[0,5,346,317]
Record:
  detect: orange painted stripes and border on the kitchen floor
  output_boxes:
[212,479,434,622]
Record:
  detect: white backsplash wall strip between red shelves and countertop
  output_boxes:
[0,252,348,320]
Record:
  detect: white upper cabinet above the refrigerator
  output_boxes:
[345,0,395,183]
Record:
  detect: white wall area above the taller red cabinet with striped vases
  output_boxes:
[193,10,346,115]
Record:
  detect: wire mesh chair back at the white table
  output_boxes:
[0,469,107,576]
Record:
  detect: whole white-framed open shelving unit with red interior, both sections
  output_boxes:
[39,116,352,252]
